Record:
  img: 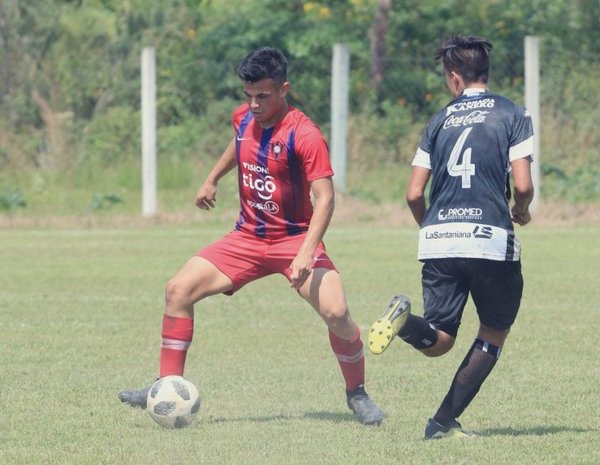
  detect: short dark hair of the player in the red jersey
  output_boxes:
[238,47,287,84]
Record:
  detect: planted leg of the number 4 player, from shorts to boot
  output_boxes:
[425,260,523,437]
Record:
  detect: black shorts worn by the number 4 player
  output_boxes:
[421,258,523,337]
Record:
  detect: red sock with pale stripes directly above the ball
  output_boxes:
[160,315,194,378]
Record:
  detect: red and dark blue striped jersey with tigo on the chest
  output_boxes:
[233,104,333,239]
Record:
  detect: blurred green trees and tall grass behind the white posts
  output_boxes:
[0,0,600,222]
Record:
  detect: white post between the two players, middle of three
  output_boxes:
[331,44,350,192]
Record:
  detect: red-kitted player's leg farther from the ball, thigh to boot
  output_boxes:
[299,268,383,425]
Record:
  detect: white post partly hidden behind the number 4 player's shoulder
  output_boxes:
[525,36,541,213]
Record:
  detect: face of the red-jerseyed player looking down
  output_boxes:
[244,78,290,128]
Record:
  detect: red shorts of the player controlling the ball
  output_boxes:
[196,230,337,295]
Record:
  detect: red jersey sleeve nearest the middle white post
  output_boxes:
[295,122,333,182]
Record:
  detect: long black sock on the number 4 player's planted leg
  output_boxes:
[433,339,500,426]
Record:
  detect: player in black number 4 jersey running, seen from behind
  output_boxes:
[369,36,533,439]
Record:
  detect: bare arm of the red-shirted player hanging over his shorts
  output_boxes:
[290,176,335,289]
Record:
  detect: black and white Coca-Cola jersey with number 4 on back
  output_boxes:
[412,89,533,261]
